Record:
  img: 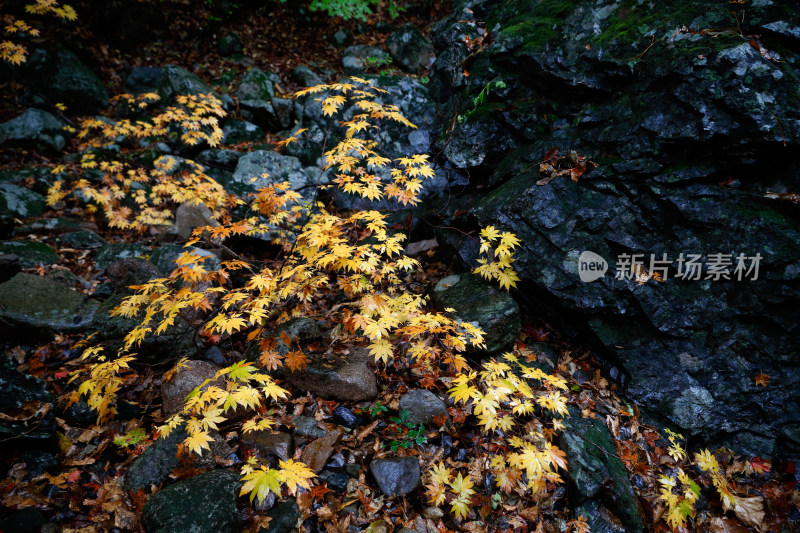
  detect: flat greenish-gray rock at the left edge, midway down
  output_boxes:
[0,272,98,338]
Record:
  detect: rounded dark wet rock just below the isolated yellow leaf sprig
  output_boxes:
[432,274,522,354]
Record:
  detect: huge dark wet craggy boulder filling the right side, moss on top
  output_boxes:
[431,0,800,459]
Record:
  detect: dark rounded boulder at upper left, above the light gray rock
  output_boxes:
[20,45,108,113]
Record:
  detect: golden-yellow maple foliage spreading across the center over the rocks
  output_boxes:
[67,78,524,510]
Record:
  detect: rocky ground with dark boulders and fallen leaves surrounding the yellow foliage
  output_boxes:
[0,2,800,532]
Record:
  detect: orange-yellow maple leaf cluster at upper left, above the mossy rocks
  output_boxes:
[47,93,228,232]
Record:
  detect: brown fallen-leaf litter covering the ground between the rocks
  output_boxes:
[0,3,800,533]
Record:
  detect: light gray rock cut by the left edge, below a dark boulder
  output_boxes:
[0,108,67,152]
